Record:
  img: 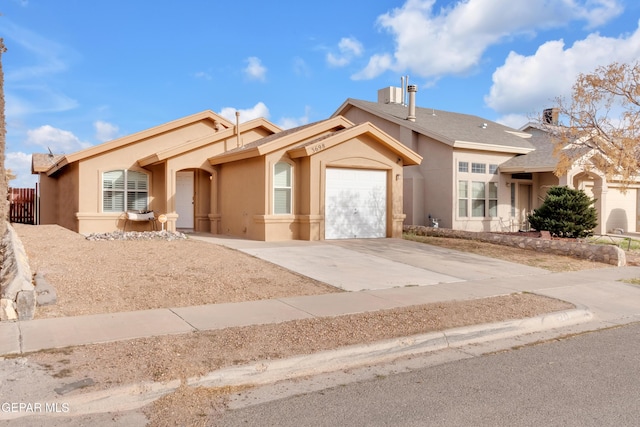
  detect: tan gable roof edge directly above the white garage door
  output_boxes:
[289,122,422,166]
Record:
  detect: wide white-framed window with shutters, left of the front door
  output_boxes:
[102,169,149,212]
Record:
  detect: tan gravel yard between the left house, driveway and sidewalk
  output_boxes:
[14,224,341,318]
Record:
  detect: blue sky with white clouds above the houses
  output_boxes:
[0,0,640,187]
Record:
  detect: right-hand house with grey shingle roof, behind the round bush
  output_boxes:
[334,85,640,234]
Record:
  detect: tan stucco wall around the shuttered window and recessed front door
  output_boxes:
[41,120,270,234]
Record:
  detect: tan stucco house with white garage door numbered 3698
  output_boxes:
[32,111,421,240]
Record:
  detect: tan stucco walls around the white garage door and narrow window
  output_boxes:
[212,135,404,241]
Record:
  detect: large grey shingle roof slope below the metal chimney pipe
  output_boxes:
[336,98,533,149]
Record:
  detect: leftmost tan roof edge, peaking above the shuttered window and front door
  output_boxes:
[47,110,235,175]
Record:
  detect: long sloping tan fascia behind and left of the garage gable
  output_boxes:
[209,116,353,166]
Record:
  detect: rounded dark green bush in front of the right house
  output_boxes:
[528,186,598,237]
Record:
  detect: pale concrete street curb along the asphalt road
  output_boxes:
[0,308,593,420]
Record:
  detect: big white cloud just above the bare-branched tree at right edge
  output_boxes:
[485,24,640,114]
